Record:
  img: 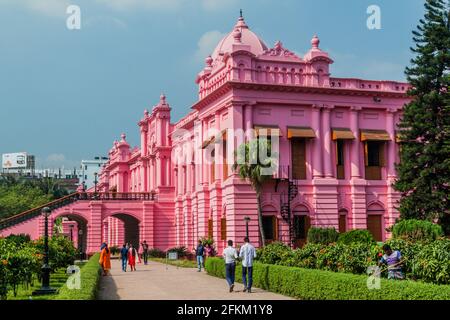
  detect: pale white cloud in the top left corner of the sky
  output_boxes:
[0,0,71,18]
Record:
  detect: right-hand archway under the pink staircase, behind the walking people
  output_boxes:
[103,213,140,249]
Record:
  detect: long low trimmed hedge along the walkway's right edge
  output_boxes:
[206,258,450,300]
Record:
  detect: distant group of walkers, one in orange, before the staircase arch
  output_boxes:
[99,240,148,276]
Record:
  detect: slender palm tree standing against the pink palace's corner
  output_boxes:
[233,138,276,246]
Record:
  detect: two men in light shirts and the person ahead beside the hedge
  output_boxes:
[195,237,256,293]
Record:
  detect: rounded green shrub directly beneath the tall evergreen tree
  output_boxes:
[392,219,444,241]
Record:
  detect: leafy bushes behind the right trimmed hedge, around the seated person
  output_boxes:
[257,238,450,284]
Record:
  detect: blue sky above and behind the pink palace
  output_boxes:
[0,0,423,167]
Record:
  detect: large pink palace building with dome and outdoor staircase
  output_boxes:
[0,17,409,252]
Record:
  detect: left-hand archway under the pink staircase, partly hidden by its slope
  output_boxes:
[53,214,88,260]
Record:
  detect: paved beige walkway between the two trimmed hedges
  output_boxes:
[98,260,290,300]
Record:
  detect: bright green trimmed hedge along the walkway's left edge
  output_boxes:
[54,253,102,300]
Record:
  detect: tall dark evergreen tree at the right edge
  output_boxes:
[395,0,450,233]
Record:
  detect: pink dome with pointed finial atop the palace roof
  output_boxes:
[211,16,267,60]
